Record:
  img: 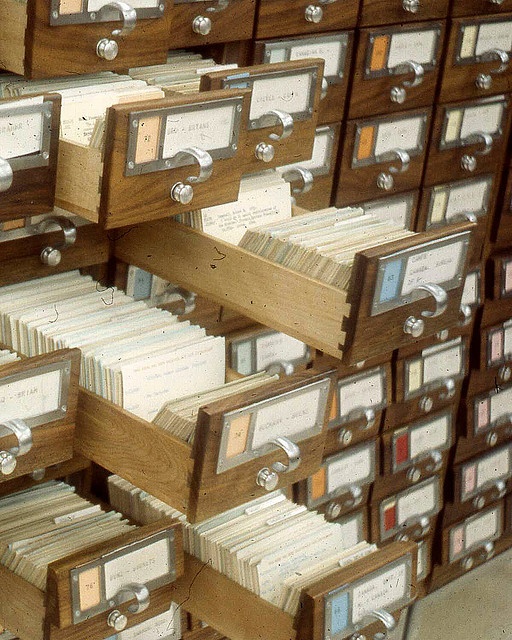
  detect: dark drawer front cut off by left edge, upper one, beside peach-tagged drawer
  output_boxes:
[0,95,60,222]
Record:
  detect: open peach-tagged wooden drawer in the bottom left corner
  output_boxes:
[0,519,183,640]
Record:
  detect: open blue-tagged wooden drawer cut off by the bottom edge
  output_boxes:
[173,543,417,640]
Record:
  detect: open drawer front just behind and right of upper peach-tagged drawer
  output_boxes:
[201,59,324,173]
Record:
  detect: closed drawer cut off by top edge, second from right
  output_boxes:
[359,0,449,27]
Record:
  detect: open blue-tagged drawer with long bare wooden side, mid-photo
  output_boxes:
[114,220,473,364]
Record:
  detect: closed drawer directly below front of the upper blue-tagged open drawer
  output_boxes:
[325,363,392,453]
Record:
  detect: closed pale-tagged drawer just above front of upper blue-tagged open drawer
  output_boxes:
[416,174,498,265]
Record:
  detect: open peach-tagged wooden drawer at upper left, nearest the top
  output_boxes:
[56,90,249,229]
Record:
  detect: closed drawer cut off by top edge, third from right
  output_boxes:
[255,0,359,39]
